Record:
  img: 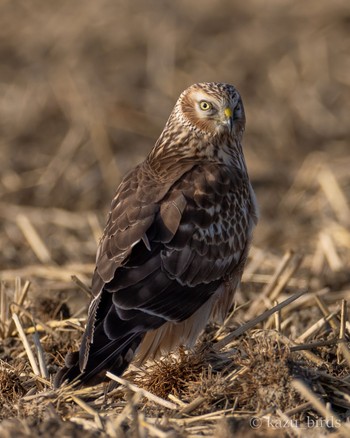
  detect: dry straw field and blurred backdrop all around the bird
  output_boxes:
[0,0,350,438]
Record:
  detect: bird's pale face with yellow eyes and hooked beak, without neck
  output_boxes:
[179,82,245,137]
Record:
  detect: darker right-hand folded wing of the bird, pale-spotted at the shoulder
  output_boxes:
[104,165,252,324]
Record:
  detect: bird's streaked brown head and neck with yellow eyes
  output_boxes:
[149,82,245,174]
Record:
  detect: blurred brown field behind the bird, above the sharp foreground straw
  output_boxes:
[0,0,350,277]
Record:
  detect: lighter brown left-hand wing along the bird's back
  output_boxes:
[79,161,193,370]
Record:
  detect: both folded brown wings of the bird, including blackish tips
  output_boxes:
[56,164,252,383]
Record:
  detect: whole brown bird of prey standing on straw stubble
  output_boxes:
[54,82,259,388]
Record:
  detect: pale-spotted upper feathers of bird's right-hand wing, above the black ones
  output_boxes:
[161,165,252,287]
